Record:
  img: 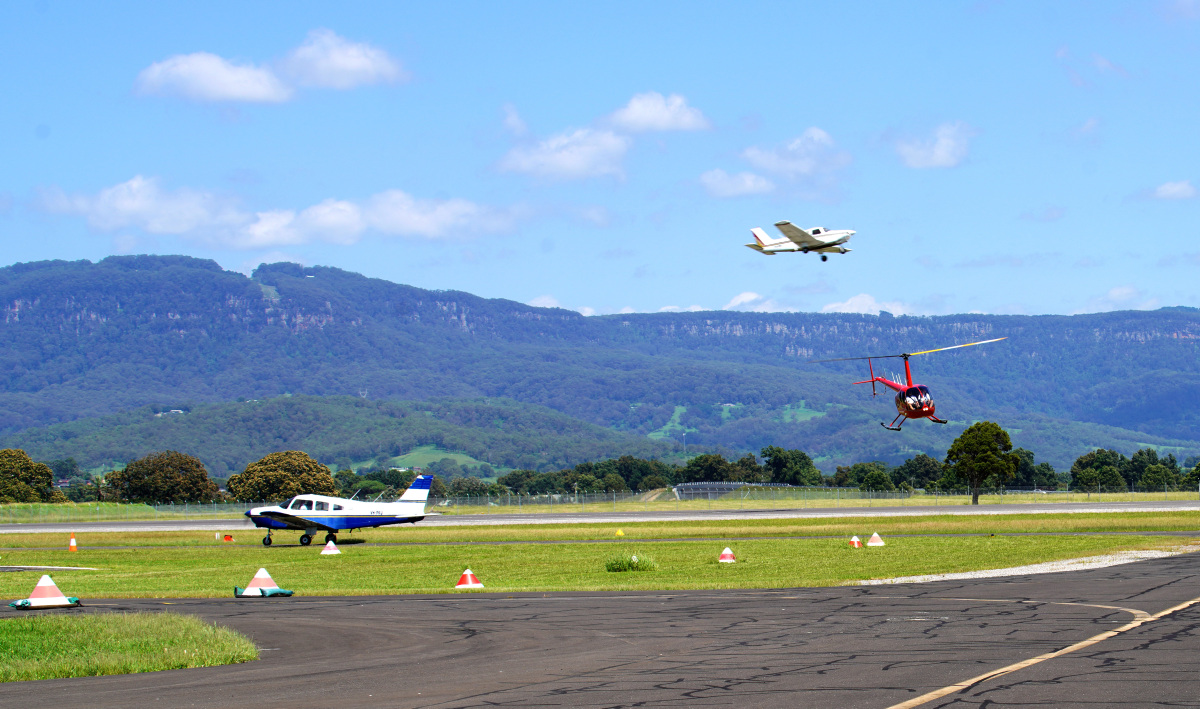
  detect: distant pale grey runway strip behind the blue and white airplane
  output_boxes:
[0,499,1200,534]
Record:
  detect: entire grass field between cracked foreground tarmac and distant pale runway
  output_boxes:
[0,512,1200,602]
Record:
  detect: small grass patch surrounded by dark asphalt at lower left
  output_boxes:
[0,613,258,681]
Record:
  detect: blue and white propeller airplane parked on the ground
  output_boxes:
[246,475,433,547]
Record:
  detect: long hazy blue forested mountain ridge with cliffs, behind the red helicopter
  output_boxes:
[0,256,1200,468]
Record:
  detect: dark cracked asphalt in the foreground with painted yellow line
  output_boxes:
[0,554,1200,709]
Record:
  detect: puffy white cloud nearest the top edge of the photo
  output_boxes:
[281,29,408,89]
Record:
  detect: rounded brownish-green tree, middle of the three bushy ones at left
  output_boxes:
[104,451,220,503]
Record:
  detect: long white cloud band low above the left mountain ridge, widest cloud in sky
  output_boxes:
[40,175,520,248]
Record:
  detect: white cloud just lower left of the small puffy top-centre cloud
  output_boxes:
[499,128,631,180]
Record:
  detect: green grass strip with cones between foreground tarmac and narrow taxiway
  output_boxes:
[0,532,1190,602]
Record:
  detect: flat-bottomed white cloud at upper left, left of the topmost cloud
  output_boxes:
[134,52,292,103]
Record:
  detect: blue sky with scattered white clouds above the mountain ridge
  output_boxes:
[0,0,1200,316]
